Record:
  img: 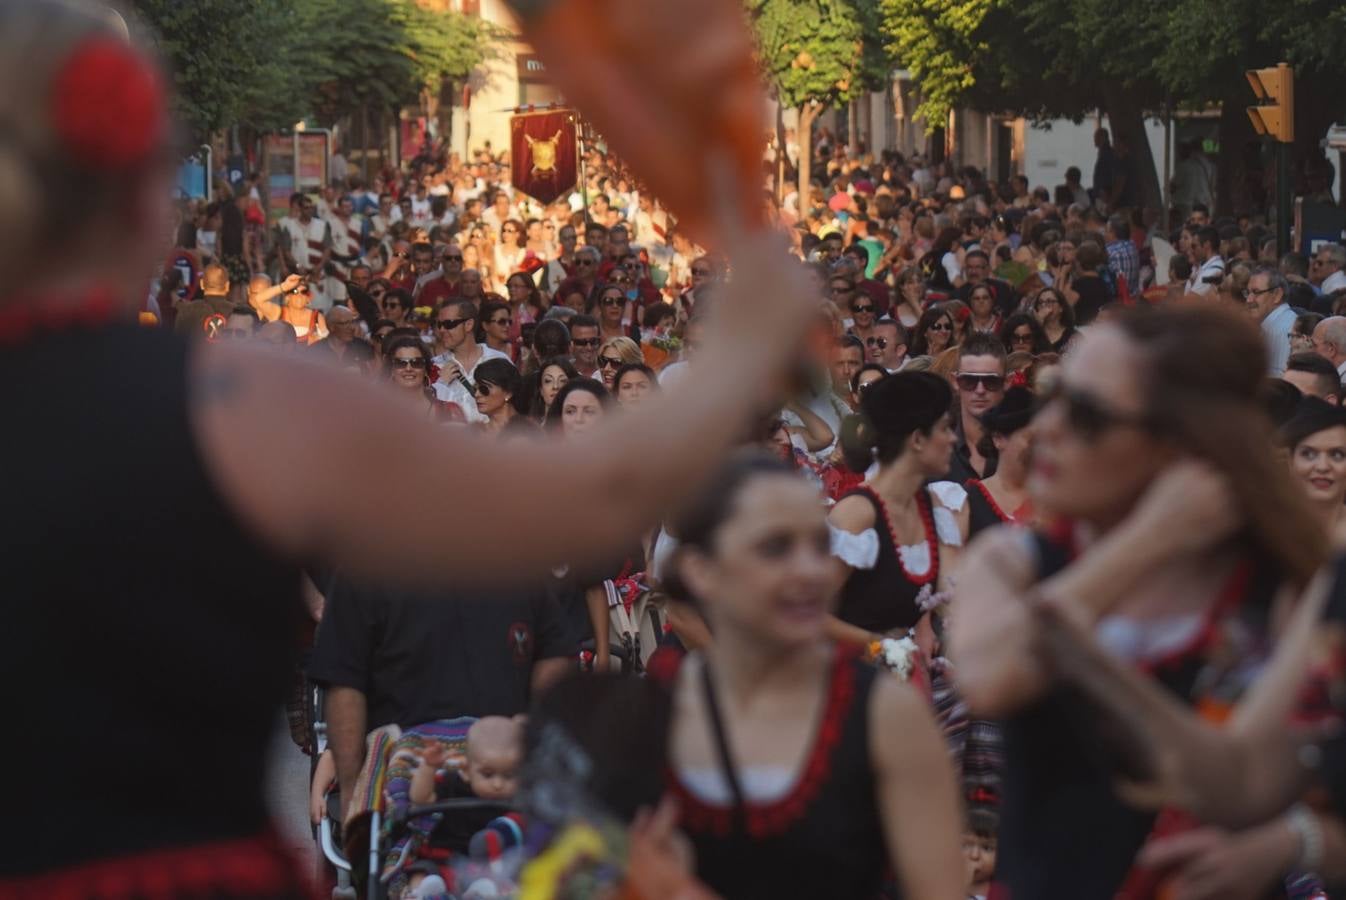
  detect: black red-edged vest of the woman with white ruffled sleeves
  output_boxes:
[837,487,940,634]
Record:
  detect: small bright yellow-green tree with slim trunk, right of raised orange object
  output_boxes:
[747,0,890,201]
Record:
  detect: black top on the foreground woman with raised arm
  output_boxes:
[0,324,300,871]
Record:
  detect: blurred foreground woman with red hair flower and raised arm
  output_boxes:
[0,0,810,897]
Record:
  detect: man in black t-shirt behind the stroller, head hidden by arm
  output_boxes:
[308,581,576,796]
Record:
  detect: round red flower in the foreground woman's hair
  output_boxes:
[50,38,168,171]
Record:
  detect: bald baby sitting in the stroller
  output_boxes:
[408,716,524,897]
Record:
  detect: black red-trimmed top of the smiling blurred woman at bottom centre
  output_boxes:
[669,646,887,900]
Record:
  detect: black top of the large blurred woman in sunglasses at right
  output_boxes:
[996,534,1279,900]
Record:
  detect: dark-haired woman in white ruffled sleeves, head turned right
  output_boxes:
[828,371,966,644]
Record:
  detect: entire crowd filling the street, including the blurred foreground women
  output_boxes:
[0,0,1346,900]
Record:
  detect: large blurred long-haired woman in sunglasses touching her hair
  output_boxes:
[952,307,1326,897]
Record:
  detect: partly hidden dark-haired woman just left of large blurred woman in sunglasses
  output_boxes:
[964,386,1035,537]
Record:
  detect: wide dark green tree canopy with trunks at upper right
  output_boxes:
[882,0,1346,206]
